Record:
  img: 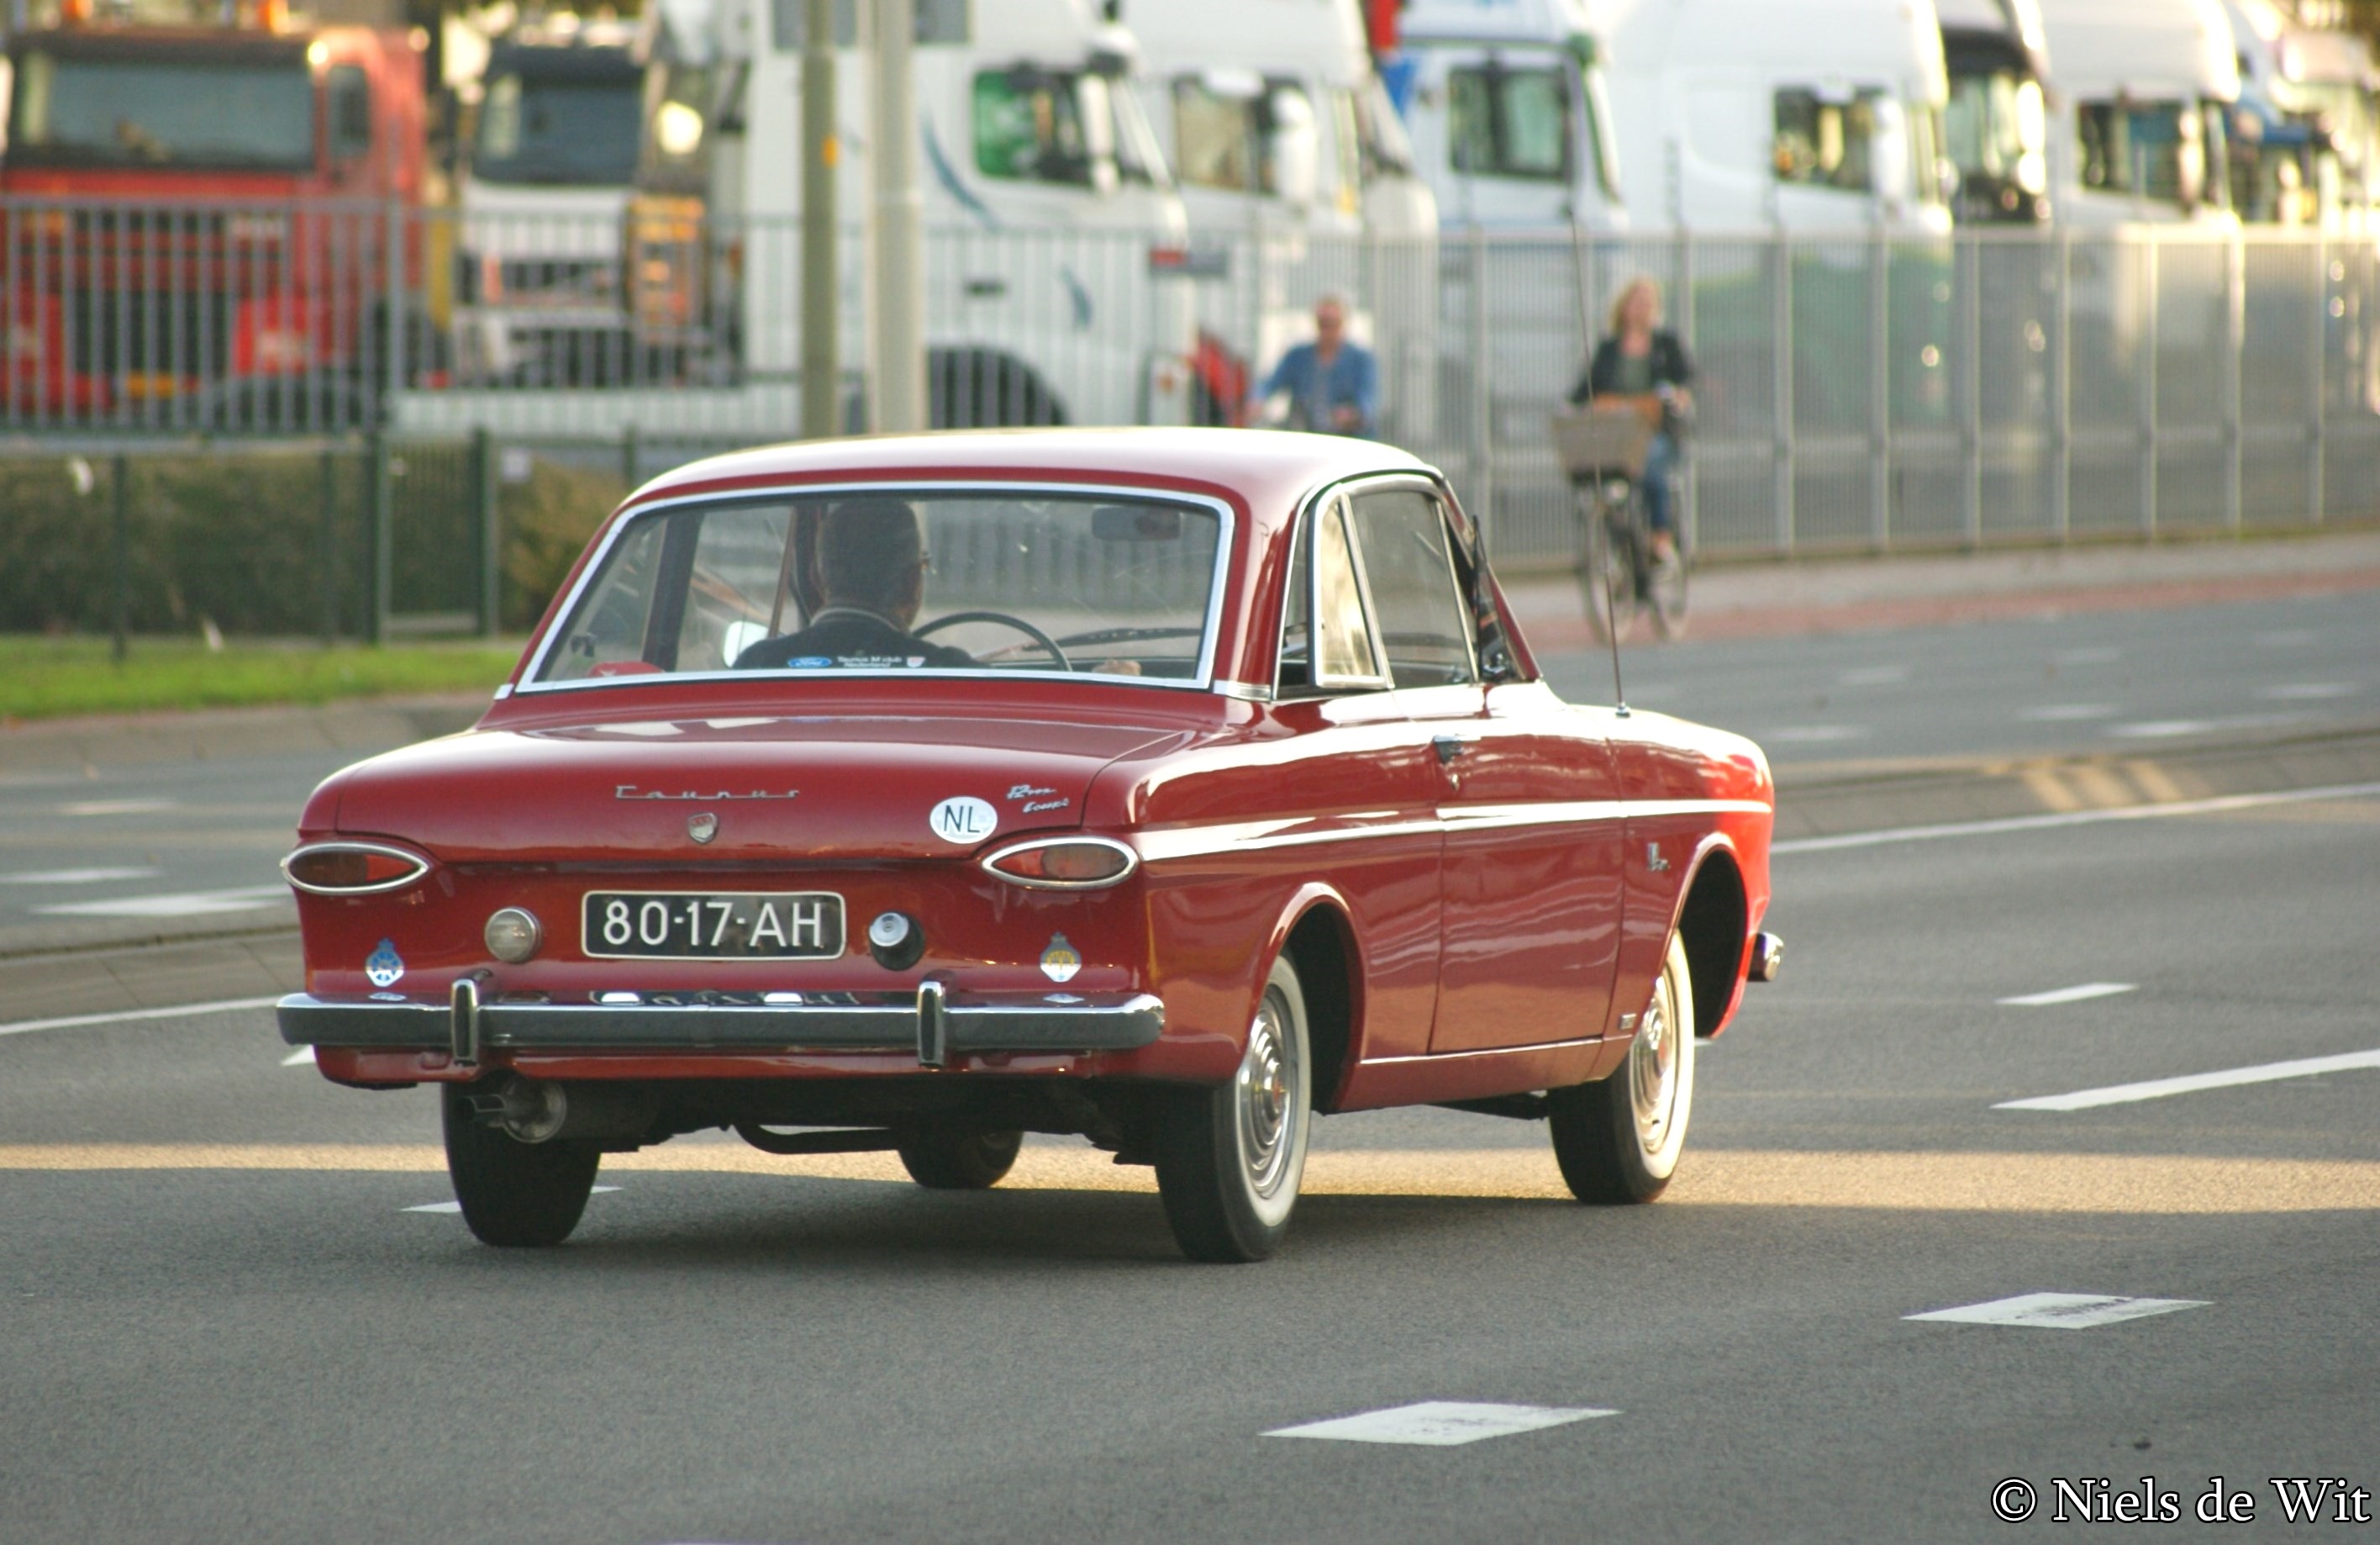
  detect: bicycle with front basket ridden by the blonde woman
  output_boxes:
[1554,398,1685,643]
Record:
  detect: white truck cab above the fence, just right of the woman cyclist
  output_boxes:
[1607,0,1949,235]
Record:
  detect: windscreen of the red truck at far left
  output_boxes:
[7,48,314,171]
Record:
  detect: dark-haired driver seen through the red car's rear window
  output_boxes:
[735,498,976,672]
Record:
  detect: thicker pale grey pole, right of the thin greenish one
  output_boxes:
[873,0,926,433]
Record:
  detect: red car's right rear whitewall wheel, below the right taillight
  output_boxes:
[1156,959,1314,1262]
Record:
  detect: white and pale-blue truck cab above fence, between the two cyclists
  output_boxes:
[1397,0,1628,231]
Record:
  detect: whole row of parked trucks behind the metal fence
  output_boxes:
[0,0,2380,426]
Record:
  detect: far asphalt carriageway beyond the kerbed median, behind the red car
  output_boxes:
[0,593,2380,955]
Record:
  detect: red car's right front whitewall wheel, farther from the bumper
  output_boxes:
[1547,933,1694,1205]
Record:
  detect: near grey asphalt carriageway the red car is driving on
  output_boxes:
[0,785,2380,1545]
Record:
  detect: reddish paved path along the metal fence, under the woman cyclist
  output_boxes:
[1504,529,2380,655]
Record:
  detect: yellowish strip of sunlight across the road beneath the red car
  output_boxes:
[0,1142,2380,1216]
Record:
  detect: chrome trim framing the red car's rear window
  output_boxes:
[512,478,1240,698]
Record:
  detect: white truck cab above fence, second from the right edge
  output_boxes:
[2042,0,2240,226]
